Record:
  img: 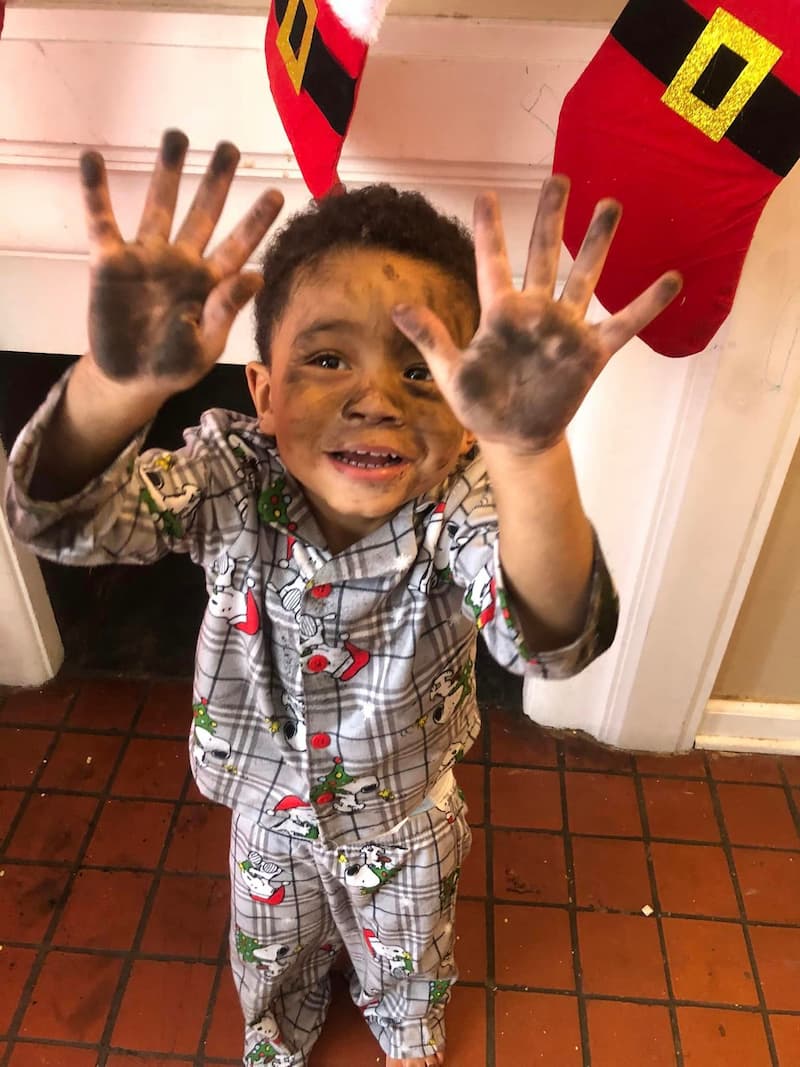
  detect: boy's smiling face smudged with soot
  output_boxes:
[247,249,475,552]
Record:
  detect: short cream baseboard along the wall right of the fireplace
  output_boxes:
[694,700,800,755]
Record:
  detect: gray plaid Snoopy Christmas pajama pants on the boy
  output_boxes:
[230,789,471,1067]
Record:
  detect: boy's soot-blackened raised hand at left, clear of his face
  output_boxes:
[80,130,283,395]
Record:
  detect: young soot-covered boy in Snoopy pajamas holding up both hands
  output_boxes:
[7,131,679,1067]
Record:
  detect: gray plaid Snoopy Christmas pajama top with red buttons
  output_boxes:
[6,376,618,845]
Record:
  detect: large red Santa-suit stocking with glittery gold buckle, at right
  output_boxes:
[554,0,800,356]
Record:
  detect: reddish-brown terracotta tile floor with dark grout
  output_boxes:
[0,681,800,1067]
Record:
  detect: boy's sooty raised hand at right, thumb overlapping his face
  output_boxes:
[394,176,682,452]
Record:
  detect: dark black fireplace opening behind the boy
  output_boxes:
[0,352,522,707]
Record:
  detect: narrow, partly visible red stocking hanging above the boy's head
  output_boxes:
[265,0,388,197]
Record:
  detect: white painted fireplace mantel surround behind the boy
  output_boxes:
[0,6,800,751]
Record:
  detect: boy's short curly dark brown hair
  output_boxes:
[255,182,479,363]
